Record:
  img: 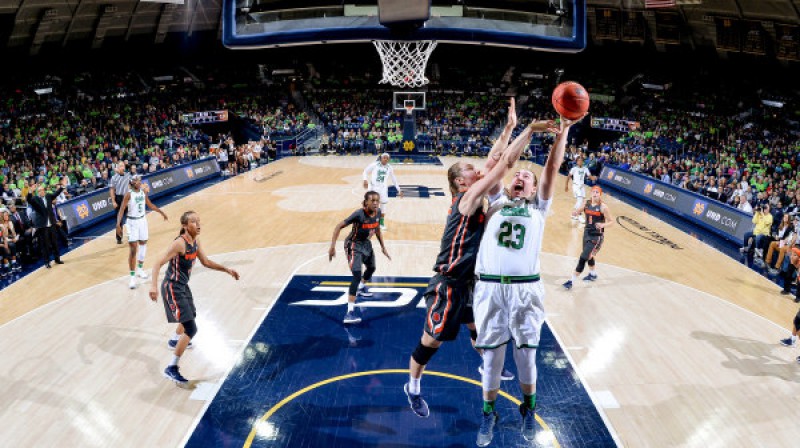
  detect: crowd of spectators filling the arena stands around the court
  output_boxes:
[0,55,800,284]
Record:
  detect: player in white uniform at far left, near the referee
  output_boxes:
[117,175,167,289]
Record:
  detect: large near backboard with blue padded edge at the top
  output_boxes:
[222,0,586,53]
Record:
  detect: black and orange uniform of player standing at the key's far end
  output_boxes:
[344,208,381,295]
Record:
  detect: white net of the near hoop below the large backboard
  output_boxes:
[372,40,436,89]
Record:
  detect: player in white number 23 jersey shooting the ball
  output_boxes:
[473,117,574,446]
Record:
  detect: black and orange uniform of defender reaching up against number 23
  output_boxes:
[425,193,486,341]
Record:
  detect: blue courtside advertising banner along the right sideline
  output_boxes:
[598,166,753,244]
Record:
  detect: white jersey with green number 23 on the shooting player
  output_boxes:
[475,194,551,276]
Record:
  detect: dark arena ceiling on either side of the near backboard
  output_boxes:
[0,0,800,54]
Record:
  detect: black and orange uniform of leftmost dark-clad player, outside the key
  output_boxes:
[161,235,197,323]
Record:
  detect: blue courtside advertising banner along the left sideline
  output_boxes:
[58,157,219,233]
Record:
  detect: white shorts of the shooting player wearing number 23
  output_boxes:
[472,280,545,348]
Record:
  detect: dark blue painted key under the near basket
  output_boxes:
[187,276,615,448]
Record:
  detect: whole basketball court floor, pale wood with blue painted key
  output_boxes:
[0,156,800,447]
